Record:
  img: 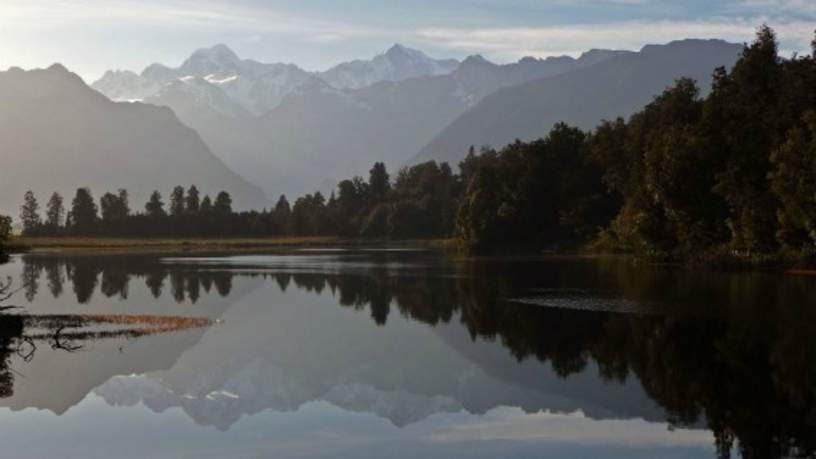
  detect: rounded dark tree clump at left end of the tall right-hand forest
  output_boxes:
[456,124,617,248]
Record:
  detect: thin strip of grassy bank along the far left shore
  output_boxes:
[7,236,453,252]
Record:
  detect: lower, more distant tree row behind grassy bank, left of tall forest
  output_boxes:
[12,158,461,238]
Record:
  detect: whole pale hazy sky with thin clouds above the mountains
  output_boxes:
[0,0,816,80]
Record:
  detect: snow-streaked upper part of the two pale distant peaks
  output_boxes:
[93,44,459,115]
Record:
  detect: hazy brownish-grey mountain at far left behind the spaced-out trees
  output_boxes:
[0,64,268,215]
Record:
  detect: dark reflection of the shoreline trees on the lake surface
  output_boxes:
[14,257,816,458]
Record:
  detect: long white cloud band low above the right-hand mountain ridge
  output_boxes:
[416,17,814,60]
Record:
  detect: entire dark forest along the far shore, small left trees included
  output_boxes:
[6,26,816,261]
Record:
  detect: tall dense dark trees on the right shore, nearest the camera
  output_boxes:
[457,26,816,260]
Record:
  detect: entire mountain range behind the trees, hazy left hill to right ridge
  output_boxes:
[0,40,742,215]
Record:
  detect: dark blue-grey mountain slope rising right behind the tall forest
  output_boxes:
[412,40,742,163]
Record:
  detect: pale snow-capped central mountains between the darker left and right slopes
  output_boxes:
[93,45,636,196]
